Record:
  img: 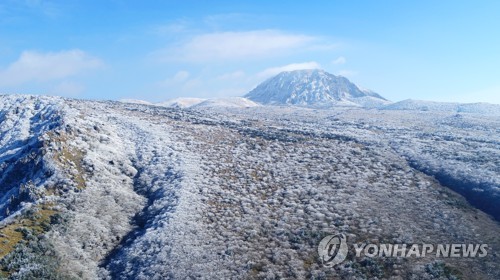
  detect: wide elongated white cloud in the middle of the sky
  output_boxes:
[157,30,315,62]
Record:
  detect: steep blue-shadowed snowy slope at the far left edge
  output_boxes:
[0,96,62,222]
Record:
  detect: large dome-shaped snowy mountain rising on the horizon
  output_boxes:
[245,69,390,108]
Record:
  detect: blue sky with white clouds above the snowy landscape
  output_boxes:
[0,0,500,104]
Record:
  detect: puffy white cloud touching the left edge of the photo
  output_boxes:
[0,50,103,86]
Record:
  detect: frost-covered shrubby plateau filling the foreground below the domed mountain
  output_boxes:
[0,94,500,279]
